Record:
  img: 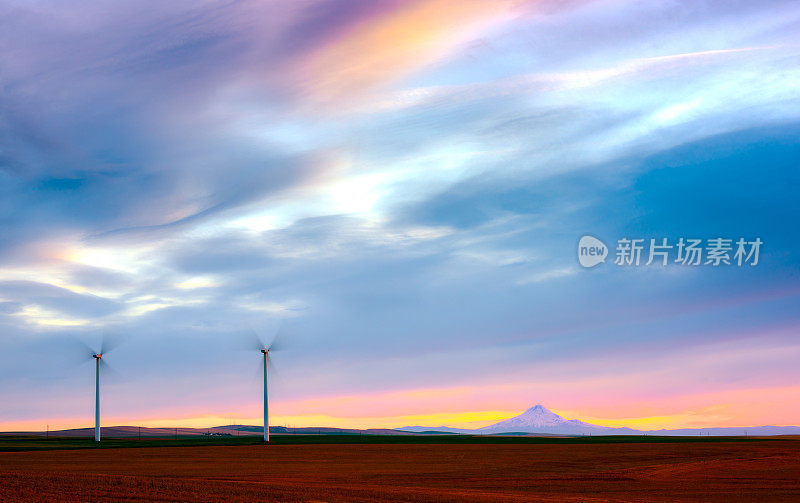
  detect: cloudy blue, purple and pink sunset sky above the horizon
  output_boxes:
[0,0,800,430]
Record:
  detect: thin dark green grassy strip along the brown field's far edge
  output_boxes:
[0,435,773,452]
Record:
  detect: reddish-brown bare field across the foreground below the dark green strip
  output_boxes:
[0,439,800,502]
